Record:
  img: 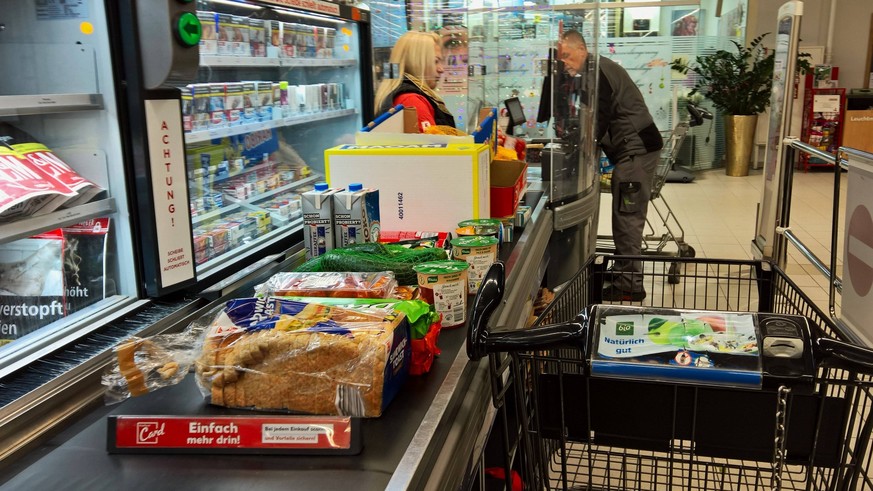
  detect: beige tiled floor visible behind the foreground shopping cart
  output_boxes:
[632,169,846,318]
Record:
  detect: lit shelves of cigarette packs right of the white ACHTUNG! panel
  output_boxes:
[182,1,368,277]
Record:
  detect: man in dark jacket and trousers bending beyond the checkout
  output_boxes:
[560,30,664,301]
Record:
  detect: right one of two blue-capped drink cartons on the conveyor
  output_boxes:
[333,183,380,248]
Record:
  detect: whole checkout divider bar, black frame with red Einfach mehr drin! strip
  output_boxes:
[107,416,361,455]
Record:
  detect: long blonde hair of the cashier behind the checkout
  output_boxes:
[375,31,440,113]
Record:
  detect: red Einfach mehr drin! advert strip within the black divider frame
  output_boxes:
[115,416,352,449]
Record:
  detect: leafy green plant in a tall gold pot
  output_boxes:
[670,34,810,176]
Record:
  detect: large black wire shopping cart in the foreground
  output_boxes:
[467,256,873,491]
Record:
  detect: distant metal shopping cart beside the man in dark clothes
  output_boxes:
[596,104,712,284]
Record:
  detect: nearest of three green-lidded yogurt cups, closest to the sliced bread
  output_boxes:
[412,261,470,327]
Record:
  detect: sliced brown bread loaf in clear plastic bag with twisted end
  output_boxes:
[103,298,411,417]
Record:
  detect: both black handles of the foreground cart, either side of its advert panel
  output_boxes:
[467,261,873,374]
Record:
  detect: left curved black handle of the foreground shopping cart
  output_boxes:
[467,261,586,360]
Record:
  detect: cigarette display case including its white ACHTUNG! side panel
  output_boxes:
[111,0,372,297]
